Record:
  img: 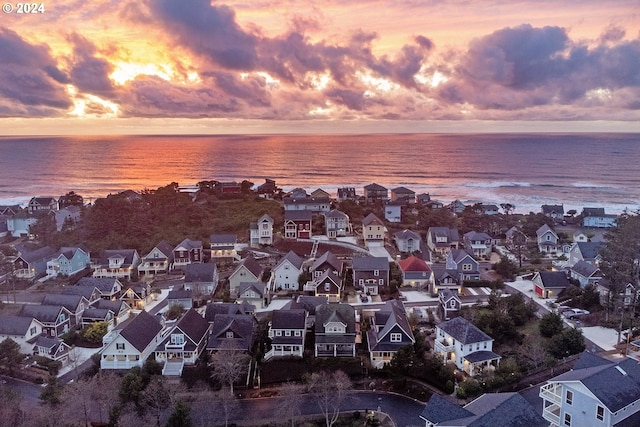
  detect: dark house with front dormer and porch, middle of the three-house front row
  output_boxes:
[314,304,356,357]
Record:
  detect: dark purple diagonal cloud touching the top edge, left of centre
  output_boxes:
[149,0,257,70]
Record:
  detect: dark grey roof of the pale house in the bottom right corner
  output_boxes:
[548,352,640,412]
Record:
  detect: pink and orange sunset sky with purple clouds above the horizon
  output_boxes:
[0,0,640,135]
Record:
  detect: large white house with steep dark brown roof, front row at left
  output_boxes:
[100,310,162,369]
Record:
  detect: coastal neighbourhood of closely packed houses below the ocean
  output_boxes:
[0,185,640,427]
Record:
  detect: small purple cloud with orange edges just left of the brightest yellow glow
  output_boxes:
[68,34,114,98]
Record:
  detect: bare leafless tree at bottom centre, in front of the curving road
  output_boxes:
[308,371,352,427]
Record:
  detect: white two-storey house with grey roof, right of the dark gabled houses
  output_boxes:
[433,317,501,376]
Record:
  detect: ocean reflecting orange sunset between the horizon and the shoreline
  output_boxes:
[0,134,640,213]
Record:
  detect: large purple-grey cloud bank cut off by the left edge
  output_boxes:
[0,28,71,116]
